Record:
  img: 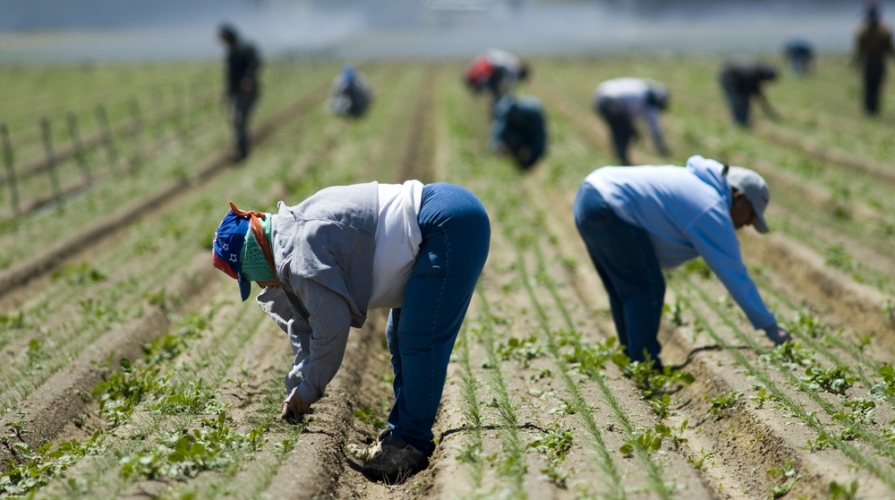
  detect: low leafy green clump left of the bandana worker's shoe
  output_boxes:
[120,411,264,480]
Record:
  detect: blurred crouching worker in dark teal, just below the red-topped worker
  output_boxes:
[489,94,547,170]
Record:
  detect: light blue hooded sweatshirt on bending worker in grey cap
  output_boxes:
[585,156,777,328]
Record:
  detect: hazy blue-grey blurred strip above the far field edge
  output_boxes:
[0,0,880,63]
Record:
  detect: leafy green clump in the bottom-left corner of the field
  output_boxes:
[0,431,105,495]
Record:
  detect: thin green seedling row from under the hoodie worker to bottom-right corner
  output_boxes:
[676,278,895,489]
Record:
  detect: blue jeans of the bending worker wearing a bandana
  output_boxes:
[385,183,491,453]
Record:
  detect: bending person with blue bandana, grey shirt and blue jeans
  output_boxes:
[213,181,491,484]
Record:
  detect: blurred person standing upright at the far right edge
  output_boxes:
[854,2,895,115]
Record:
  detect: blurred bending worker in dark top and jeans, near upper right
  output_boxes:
[720,61,778,127]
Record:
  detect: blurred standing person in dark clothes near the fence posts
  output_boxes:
[218,24,261,160]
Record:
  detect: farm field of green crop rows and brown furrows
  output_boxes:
[0,57,895,499]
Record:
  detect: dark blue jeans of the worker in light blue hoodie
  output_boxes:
[574,182,665,361]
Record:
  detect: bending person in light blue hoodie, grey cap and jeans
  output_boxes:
[574,156,789,366]
